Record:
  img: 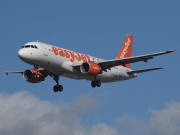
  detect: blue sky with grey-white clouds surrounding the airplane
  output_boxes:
[0,0,180,135]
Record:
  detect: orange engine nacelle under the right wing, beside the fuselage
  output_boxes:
[80,62,102,75]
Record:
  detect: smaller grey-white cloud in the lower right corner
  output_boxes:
[117,101,180,135]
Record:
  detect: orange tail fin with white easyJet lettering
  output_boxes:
[116,35,133,68]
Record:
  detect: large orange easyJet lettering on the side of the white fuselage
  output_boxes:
[52,46,99,62]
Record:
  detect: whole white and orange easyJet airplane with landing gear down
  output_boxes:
[5,34,176,92]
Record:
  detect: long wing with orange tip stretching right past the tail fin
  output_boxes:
[96,50,176,70]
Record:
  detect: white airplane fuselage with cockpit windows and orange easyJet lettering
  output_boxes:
[18,42,136,82]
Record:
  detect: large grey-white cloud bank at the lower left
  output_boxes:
[0,92,119,135]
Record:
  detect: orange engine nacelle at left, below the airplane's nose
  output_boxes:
[23,69,45,83]
